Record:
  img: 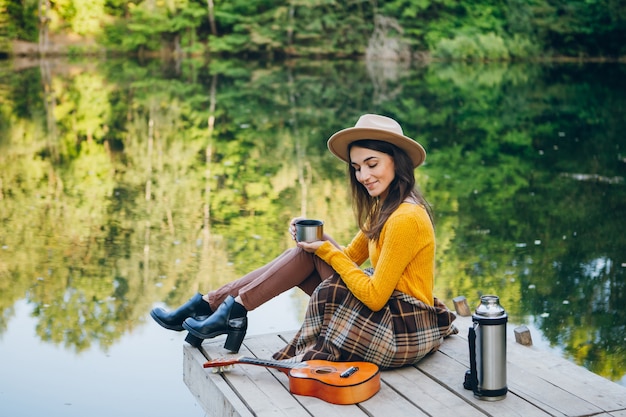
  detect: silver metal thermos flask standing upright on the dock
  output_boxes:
[463,295,508,401]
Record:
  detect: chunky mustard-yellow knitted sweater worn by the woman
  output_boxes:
[315,203,435,311]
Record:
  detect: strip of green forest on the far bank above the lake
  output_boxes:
[0,0,626,60]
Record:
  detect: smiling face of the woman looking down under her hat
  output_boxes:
[350,146,396,199]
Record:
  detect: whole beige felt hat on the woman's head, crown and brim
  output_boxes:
[328,114,426,168]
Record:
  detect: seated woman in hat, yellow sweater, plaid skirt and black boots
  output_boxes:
[151,114,456,368]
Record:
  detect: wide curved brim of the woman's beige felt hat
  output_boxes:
[328,127,426,168]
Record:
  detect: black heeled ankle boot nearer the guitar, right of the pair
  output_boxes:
[183,296,248,352]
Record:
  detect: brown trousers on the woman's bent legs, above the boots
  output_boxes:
[208,247,335,311]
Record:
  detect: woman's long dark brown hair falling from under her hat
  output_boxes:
[348,139,434,240]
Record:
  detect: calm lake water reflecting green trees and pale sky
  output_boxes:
[0,60,626,417]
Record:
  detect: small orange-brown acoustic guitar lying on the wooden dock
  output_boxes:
[203,357,380,404]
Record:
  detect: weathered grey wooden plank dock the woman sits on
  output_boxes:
[183,317,626,417]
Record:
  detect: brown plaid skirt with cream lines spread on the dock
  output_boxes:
[272,274,458,369]
